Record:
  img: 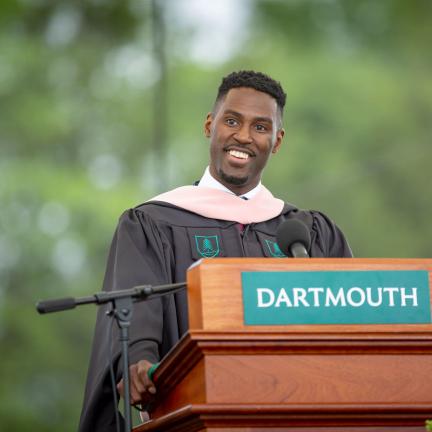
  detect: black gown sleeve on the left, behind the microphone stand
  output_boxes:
[79,209,172,432]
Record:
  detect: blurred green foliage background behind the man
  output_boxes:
[0,0,432,431]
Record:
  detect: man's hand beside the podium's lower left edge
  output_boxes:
[117,360,156,405]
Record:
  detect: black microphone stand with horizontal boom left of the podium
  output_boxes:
[36,282,186,432]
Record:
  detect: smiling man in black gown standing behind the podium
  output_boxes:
[80,71,351,432]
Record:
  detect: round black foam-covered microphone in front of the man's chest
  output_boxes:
[276,219,311,258]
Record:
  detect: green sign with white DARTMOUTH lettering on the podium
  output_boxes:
[242,271,431,325]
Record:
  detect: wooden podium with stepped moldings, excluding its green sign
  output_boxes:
[134,258,432,432]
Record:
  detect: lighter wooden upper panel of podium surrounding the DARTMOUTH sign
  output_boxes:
[188,258,432,333]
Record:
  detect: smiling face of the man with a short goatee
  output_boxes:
[204,87,284,195]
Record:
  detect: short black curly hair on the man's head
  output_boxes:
[215,70,286,116]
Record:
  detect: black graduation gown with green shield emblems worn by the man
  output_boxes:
[79,201,352,432]
